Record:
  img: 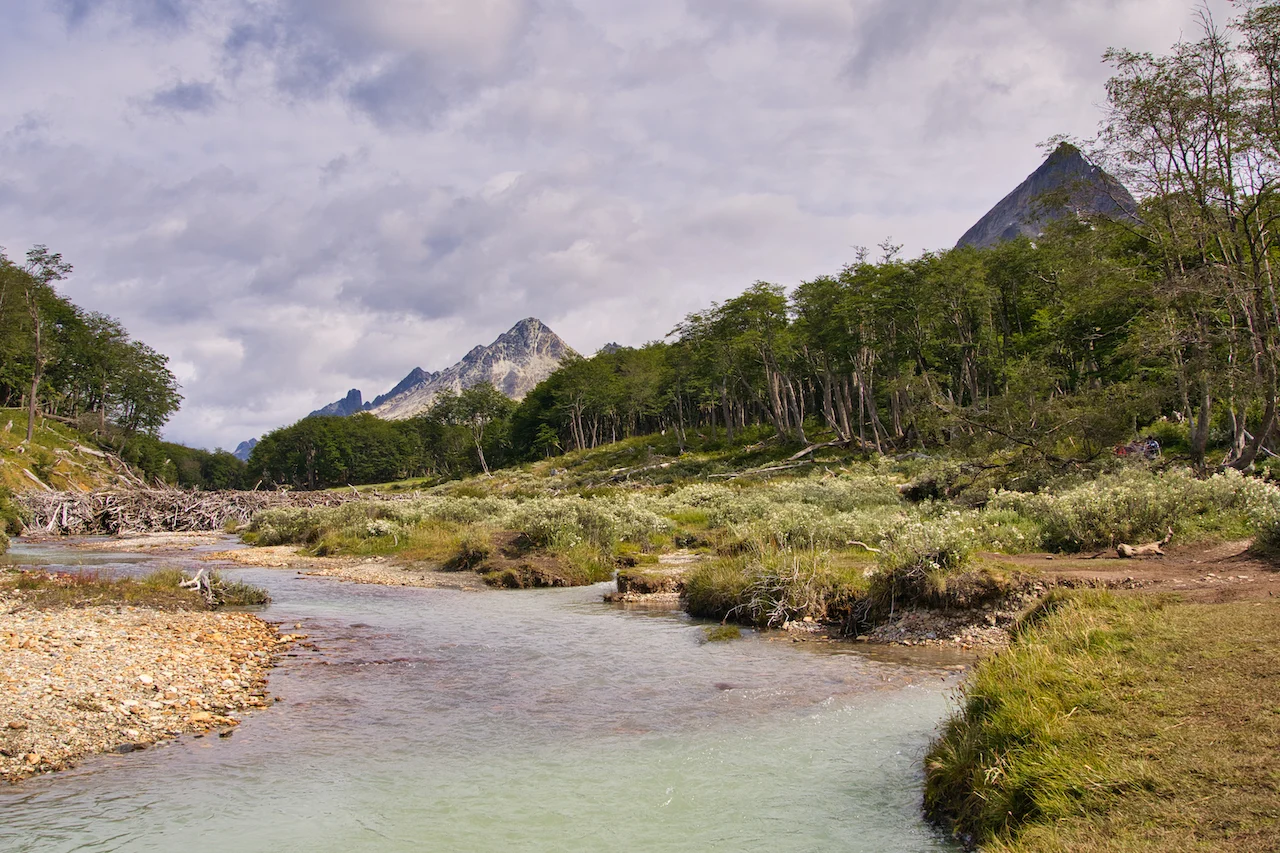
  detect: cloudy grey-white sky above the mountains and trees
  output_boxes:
[0,0,1230,450]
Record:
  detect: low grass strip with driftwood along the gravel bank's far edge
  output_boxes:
[0,569,270,611]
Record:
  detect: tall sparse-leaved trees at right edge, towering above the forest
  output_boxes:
[1100,0,1280,469]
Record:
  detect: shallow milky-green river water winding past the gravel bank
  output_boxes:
[0,543,956,853]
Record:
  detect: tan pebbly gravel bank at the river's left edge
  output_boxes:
[0,594,301,781]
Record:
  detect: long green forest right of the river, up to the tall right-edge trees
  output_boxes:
[251,4,1280,485]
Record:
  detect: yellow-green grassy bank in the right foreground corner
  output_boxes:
[925,593,1280,853]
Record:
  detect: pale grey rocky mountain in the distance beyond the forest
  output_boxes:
[371,318,577,420]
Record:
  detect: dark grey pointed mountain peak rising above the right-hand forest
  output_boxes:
[956,142,1138,248]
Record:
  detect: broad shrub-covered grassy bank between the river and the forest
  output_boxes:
[254,450,1280,612]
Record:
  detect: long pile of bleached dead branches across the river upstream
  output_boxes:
[17,489,370,535]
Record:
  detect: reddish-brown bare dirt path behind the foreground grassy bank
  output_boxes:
[980,539,1280,605]
